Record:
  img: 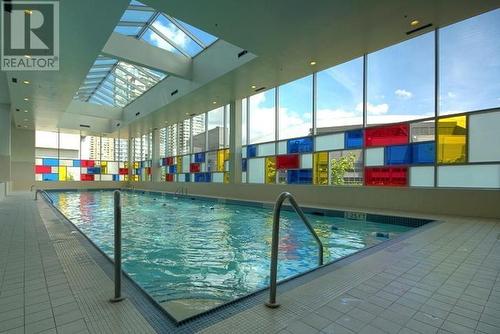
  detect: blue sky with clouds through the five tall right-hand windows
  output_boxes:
[249,9,500,143]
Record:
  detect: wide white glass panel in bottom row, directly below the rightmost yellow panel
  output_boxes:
[438,165,500,188]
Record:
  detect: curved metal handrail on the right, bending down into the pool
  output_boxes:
[266,192,323,308]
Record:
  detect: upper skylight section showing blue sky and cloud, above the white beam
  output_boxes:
[115,1,217,57]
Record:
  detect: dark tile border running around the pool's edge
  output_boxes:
[42,189,440,334]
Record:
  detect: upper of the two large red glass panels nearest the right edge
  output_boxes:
[365,124,410,147]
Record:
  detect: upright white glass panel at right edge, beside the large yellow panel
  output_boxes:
[469,112,500,162]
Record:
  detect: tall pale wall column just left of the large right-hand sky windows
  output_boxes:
[229,99,241,184]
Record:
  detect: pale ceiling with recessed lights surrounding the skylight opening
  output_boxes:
[0,0,500,136]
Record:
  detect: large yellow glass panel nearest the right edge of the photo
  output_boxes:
[437,116,467,164]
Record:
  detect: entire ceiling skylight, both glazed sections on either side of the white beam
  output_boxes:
[74,0,217,107]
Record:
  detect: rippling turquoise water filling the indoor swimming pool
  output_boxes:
[50,191,411,303]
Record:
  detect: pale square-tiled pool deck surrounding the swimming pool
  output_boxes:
[0,193,500,334]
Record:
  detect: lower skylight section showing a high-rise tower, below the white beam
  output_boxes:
[75,56,166,107]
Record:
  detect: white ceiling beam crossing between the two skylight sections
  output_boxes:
[102,33,192,80]
